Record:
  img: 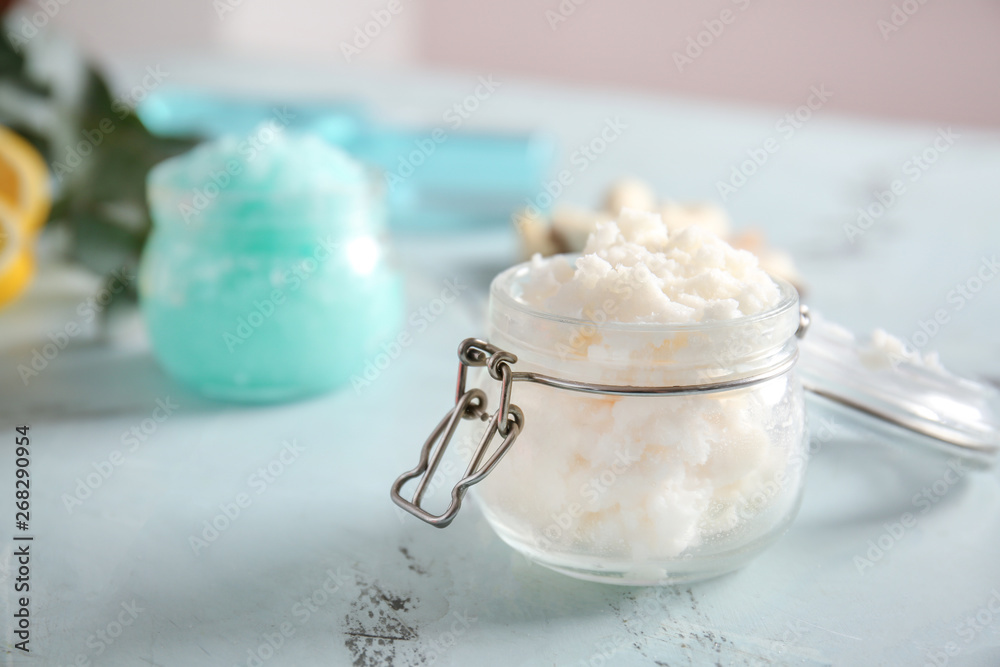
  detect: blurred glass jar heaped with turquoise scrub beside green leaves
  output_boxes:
[139,130,403,402]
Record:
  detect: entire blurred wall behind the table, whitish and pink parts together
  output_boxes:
[39,0,1000,127]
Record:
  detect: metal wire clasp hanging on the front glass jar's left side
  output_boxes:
[392,338,524,528]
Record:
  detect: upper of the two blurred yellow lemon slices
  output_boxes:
[0,126,51,233]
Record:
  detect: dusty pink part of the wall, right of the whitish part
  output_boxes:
[422,0,1000,126]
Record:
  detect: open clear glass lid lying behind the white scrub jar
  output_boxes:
[799,314,1000,467]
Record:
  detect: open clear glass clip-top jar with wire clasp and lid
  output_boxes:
[391,264,1000,585]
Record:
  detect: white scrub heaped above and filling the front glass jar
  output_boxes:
[477,209,805,583]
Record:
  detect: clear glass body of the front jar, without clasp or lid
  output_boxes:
[476,267,807,584]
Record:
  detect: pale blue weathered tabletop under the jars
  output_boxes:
[0,62,1000,667]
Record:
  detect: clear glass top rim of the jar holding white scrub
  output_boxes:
[490,260,799,333]
